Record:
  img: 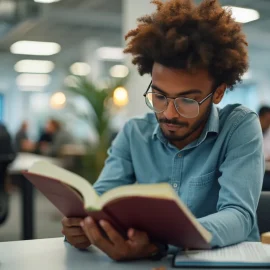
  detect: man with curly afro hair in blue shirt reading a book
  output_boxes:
[62,0,264,260]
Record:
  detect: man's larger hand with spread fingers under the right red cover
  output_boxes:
[81,217,157,261]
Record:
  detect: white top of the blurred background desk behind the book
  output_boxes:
[8,153,62,174]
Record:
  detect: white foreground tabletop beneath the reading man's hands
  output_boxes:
[0,238,172,270]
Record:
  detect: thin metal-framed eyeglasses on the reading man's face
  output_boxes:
[143,82,214,118]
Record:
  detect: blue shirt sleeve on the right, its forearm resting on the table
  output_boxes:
[198,113,264,247]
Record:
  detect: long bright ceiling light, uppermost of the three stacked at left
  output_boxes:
[10,40,61,55]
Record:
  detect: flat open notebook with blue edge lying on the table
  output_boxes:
[173,242,270,269]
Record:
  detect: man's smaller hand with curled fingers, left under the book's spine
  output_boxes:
[62,217,91,249]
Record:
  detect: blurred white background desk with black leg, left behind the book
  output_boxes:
[8,153,63,240]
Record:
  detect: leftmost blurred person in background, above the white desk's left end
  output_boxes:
[15,121,36,152]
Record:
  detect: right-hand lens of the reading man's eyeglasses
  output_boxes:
[175,98,199,118]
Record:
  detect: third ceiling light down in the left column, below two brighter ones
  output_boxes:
[16,73,51,87]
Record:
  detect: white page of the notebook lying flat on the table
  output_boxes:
[175,242,270,265]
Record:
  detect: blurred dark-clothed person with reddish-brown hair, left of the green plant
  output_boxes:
[37,119,73,157]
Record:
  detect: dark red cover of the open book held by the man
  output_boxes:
[23,172,210,249]
